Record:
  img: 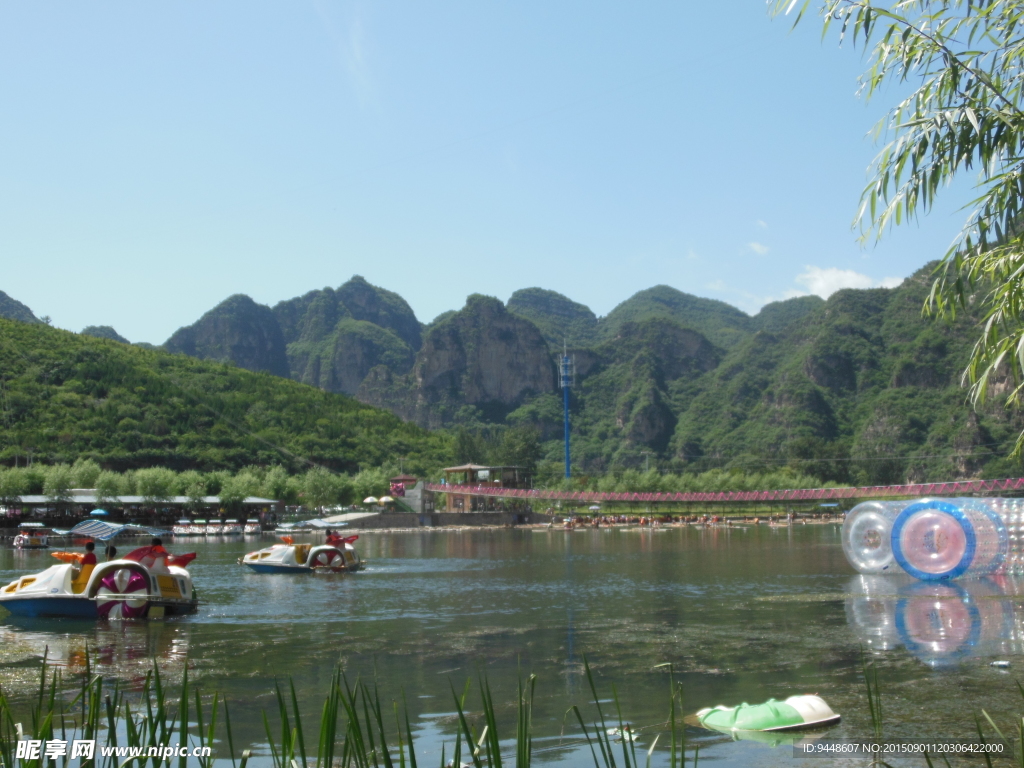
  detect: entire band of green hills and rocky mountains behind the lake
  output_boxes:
[0,260,1024,483]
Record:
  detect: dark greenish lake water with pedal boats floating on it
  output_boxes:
[0,524,1024,766]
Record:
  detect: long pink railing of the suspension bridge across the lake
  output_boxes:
[427,477,1024,504]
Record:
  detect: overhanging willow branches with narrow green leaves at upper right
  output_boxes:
[772,0,1024,455]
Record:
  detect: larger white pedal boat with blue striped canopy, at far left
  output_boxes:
[0,520,199,618]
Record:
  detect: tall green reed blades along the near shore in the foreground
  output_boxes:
[25,653,1024,768]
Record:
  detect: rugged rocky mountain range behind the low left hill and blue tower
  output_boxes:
[149,267,1024,482]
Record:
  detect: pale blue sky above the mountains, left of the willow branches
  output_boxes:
[0,0,970,343]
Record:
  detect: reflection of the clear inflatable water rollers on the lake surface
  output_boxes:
[846,575,1024,668]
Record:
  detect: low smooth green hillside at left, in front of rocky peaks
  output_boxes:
[0,321,449,472]
